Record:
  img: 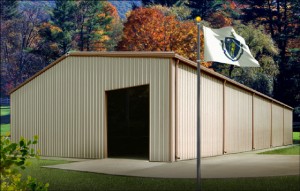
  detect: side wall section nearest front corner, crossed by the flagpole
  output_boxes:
[177,64,223,160]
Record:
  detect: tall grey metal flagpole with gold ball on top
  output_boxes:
[196,16,201,191]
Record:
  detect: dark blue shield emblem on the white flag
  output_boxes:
[221,37,243,61]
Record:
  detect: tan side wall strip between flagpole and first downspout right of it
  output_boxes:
[201,73,223,157]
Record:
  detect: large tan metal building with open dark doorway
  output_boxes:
[11,52,292,161]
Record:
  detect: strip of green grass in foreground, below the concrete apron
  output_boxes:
[17,159,300,191]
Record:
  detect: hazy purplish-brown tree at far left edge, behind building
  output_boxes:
[1,2,45,91]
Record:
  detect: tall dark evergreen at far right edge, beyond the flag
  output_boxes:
[237,0,300,106]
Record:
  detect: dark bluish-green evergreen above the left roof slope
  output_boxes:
[33,0,77,65]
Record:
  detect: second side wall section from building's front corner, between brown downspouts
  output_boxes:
[224,84,252,153]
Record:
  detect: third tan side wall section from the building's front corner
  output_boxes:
[253,96,271,149]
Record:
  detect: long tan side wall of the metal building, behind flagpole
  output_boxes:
[175,63,292,160]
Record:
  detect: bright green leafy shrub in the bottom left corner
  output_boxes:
[0,135,49,191]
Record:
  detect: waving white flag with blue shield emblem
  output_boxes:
[203,26,259,67]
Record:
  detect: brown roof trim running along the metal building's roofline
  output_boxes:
[9,51,293,109]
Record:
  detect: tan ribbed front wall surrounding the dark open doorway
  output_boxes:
[11,57,170,161]
